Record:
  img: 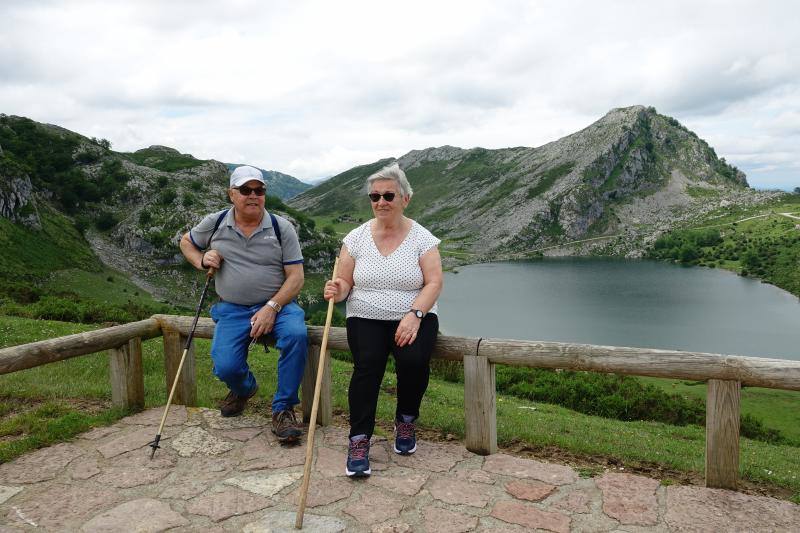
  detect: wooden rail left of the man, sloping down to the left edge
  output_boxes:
[0,318,161,374]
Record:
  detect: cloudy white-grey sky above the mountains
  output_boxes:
[0,0,800,189]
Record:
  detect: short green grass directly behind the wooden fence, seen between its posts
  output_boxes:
[0,316,800,498]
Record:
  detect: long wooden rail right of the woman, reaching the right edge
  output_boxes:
[478,339,800,390]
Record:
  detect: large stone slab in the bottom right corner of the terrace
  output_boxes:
[664,486,800,531]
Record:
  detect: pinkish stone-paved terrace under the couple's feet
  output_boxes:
[0,406,800,533]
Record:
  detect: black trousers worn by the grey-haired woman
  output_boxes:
[347,314,439,437]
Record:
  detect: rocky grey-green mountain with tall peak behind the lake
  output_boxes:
[289,106,770,261]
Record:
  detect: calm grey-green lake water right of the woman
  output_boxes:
[439,258,800,360]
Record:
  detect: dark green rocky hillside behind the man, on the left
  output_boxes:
[0,115,335,308]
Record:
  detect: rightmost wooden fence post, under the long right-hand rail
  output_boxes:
[706,379,741,490]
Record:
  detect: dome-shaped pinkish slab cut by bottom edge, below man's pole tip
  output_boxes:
[81,498,189,533]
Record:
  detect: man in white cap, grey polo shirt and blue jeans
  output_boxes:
[180,166,308,442]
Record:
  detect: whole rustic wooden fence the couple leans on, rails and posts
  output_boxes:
[0,315,800,489]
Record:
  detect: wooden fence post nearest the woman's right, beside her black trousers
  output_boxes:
[464,354,497,455]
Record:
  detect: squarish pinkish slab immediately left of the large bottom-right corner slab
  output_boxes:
[595,473,659,526]
